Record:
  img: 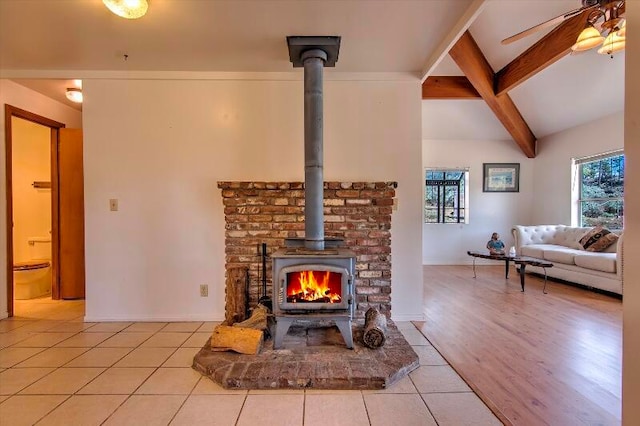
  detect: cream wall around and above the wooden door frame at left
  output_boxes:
[0,79,82,318]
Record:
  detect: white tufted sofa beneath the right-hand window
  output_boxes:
[511,225,623,295]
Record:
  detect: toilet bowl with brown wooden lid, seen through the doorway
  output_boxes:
[13,260,51,300]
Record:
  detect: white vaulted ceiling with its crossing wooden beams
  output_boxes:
[423,0,625,157]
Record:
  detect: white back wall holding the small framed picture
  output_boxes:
[421,140,534,265]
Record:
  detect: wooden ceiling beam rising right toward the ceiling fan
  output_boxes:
[495,9,592,96]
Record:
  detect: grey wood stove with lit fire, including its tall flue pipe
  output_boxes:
[271,36,355,349]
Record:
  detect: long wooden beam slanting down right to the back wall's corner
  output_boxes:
[449,31,536,158]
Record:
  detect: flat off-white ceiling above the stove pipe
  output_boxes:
[0,0,472,72]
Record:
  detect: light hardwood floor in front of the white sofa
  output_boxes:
[417,265,622,426]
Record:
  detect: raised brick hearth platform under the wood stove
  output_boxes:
[193,321,419,389]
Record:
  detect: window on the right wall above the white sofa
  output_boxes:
[575,151,624,229]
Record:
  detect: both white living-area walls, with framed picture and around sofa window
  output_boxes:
[422,112,624,265]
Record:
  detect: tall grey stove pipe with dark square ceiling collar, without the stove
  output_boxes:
[287,36,340,250]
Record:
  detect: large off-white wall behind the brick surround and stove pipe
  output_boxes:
[83,74,422,321]
